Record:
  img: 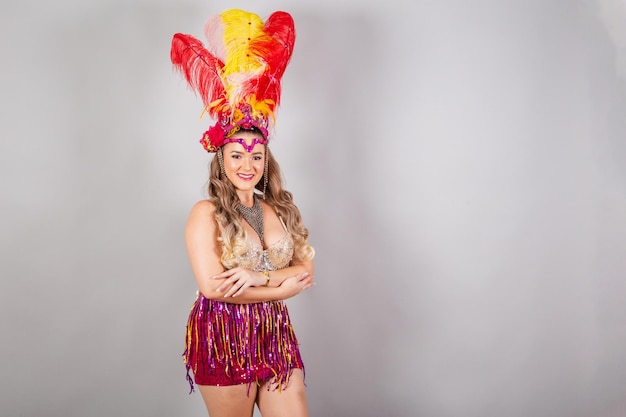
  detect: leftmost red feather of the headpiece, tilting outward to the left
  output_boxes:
[170,33,225,105]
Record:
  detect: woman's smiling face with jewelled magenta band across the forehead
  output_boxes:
[222,130,265,202]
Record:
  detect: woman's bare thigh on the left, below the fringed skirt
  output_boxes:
[198,384,257,417]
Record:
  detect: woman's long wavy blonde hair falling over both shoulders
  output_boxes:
[208,146,315,268]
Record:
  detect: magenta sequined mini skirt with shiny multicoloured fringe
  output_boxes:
[183,294,304,391]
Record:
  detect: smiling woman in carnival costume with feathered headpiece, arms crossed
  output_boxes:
[171,6,314,417]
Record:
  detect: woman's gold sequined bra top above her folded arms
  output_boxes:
[237,217,293,271]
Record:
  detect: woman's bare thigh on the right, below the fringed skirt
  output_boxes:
[255,369,309,417]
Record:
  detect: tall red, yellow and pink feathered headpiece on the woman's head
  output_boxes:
[171,9,296,152]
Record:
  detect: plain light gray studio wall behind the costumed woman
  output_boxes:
[0,0,626,417]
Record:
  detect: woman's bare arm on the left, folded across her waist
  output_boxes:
[185,200,313,304]
